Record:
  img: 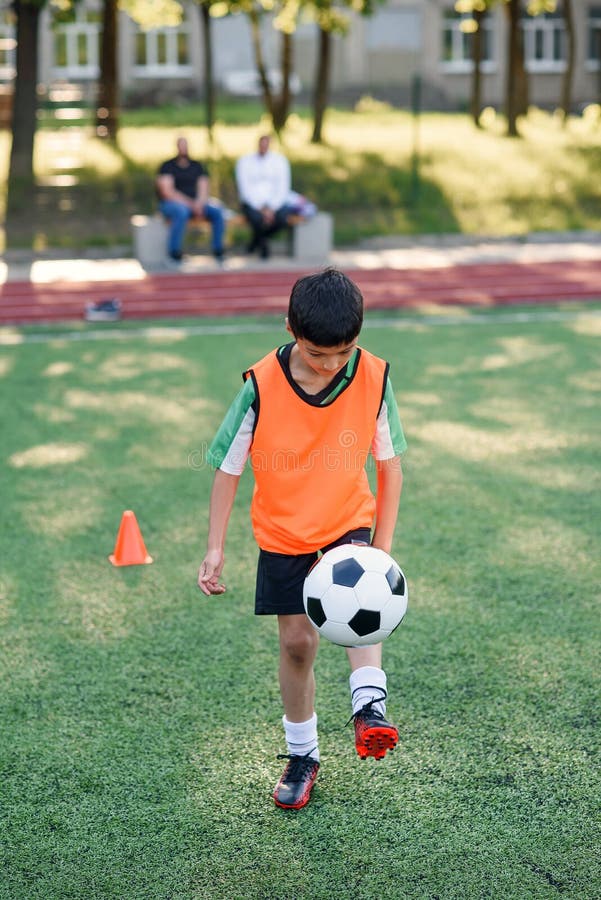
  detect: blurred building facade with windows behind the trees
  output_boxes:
[0,0,601,109]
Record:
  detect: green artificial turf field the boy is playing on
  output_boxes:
[0,306,601,900]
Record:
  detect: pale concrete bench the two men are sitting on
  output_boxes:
[131,210,334,269]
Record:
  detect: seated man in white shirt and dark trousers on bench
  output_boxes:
[236,134,291,259]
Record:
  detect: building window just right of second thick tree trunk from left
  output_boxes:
[134,14,192,78]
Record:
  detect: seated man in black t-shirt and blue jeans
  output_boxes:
[157,137,225,262]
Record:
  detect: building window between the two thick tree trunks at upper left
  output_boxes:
[52,8,101,79]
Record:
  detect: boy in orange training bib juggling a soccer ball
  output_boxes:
[198,269,406,809]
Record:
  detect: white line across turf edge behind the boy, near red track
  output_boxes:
[0,307,601,347]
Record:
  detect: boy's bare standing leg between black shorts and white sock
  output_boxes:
[278,613,319,722]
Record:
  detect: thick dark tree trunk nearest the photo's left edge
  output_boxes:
[6,0,41,245]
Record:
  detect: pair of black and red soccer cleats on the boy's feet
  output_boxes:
[273,700,399,809]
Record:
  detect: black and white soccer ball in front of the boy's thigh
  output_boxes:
[303,544,408,647]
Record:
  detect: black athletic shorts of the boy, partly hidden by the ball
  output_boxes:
[255,528,371,616]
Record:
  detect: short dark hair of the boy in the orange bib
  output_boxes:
[288,268,363,347]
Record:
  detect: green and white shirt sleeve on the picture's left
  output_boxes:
[207,378,256,475]
